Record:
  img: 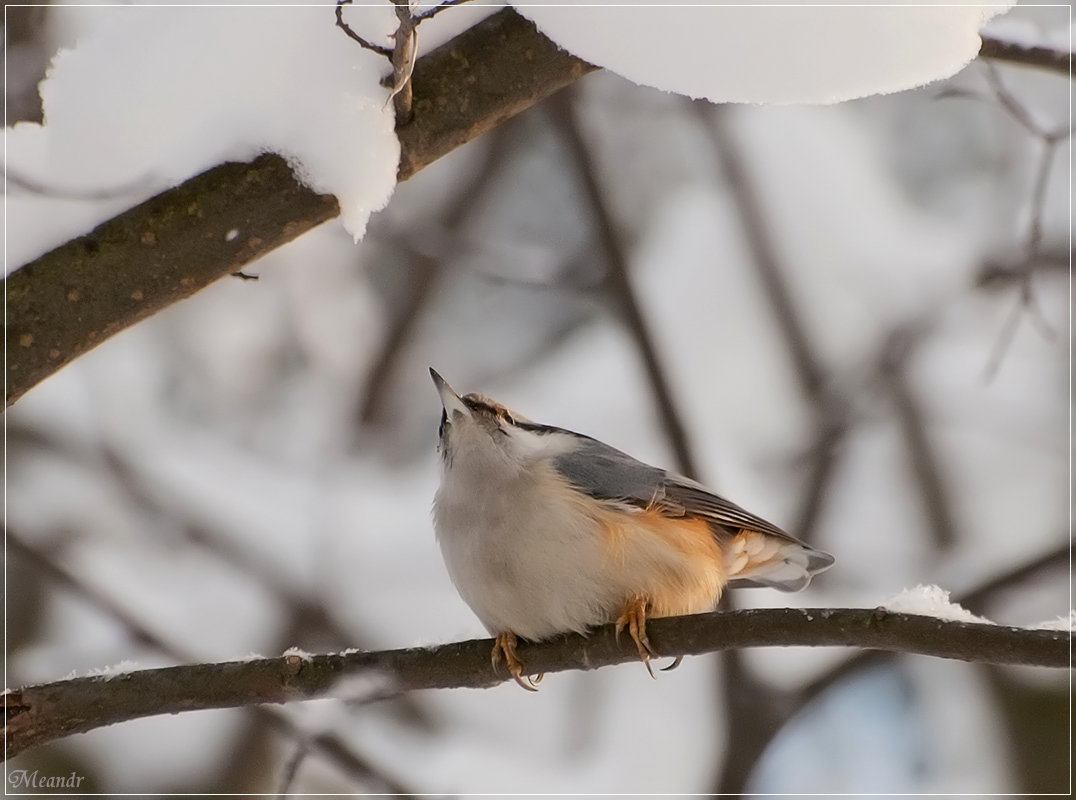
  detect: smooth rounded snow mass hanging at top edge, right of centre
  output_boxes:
[514,0,1013,103]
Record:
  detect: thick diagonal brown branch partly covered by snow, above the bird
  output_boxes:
[4,9,594,413]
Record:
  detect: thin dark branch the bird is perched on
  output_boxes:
[4,608,1070,758]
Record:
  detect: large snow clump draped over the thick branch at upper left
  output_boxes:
[5,3,399,266]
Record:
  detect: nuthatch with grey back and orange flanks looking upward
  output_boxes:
[429,369,833,689]
